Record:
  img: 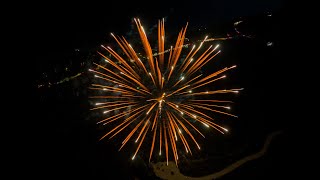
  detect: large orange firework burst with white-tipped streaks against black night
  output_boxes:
[89,19,241,165]
